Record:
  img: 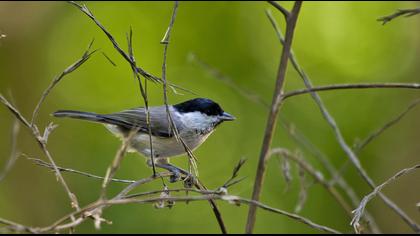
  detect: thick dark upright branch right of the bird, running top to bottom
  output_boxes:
[246,1,302,233]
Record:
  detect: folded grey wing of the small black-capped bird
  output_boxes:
[101,106,173,137]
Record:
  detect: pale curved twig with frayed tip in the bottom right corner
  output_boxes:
[350,164,420,232]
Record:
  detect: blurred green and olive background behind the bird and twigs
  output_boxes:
[0,2,420,233]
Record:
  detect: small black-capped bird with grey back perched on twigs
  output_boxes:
[53,98,235,182]
